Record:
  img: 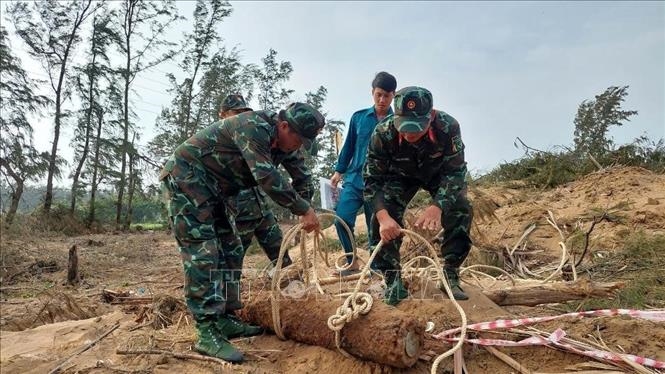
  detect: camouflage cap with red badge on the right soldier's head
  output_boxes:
[394,86,432,132]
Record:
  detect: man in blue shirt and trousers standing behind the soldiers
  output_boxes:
[330,71,397,276]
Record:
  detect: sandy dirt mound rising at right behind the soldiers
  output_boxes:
[475,167,665,257]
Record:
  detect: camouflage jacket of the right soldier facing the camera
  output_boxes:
[363,111,466,211]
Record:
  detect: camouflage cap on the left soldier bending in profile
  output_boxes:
[284,103,326,155]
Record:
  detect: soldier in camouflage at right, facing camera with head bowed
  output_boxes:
[364,87,473,305]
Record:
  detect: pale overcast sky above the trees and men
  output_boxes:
[3,1,665,178]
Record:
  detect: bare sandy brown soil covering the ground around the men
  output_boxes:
[0,168,665,374]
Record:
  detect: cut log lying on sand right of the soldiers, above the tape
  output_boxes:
[483,279,624,306]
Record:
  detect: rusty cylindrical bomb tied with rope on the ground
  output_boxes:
[240,291,425,368]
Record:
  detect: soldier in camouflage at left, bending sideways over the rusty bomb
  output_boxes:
[160,103,325,362]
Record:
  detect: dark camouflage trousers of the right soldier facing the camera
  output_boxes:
[371,181,473,284]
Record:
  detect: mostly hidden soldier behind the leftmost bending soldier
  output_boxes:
[219,95,294,267]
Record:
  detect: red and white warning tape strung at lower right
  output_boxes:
[433,309,665,369]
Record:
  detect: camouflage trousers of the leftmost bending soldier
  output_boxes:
[162,175,244,320]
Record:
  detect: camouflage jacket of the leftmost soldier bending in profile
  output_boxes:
[161,111,314,215]
